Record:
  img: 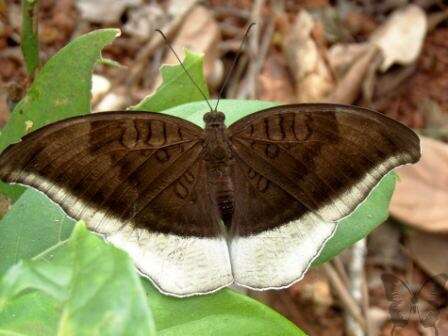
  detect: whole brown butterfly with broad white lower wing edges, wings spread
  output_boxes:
[0,104,420,297]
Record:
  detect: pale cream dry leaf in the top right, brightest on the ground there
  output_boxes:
[370,5,428,71]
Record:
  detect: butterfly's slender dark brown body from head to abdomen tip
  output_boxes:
[204,111,234,227]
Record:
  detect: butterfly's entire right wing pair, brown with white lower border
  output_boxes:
[228,104,420,288]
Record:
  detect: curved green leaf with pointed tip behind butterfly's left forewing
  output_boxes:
[0,29,119,199]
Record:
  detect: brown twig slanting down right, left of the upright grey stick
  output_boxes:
[322,263,367,330]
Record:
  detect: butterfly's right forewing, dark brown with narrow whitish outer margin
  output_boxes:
[229,104,420,221]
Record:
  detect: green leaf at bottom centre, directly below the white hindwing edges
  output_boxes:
[144,281,305,336]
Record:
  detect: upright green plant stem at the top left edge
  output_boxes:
[21,0,40,80]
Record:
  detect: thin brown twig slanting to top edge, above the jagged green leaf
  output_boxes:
[126,1,198,88]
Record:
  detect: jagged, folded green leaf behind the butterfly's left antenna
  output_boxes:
[131,50,208,112]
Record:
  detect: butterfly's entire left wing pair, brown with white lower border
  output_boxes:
[0,112,231,295]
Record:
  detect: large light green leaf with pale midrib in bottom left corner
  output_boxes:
[0,222,155,336]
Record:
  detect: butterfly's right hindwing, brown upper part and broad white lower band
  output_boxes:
[230,143,336,289]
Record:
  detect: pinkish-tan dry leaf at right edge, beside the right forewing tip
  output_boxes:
[390,137,448,232]
